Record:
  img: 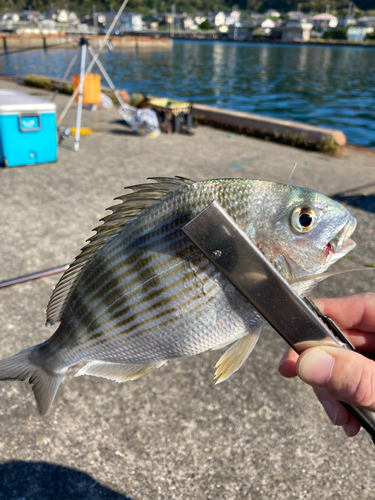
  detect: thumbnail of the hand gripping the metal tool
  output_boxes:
[298,349,335,387]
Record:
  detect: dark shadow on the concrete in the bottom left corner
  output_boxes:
[0,461,131,500]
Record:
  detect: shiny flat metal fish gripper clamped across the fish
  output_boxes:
[182,201,375,442]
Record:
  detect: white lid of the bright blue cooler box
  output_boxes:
[0,89,56,114]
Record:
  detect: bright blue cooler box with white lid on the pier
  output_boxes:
[0,89,57,167]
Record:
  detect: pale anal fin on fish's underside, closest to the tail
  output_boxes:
[74,361,165,382]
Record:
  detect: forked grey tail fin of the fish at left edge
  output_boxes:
[0,344,66,415]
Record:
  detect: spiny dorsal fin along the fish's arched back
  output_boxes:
[47,177,194,325]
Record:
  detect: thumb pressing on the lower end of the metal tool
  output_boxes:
[296,346,375,411]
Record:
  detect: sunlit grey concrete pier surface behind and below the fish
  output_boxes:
[0,80,375,500]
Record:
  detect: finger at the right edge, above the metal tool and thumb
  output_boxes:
[314,293,375,332]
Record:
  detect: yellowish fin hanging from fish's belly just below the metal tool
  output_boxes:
[215,327,262,384]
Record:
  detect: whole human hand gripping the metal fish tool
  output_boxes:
[279,293,375,437]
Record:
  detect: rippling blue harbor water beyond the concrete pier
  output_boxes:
[0,40,375,148]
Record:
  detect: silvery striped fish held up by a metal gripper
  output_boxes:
[0,177,356,415]
